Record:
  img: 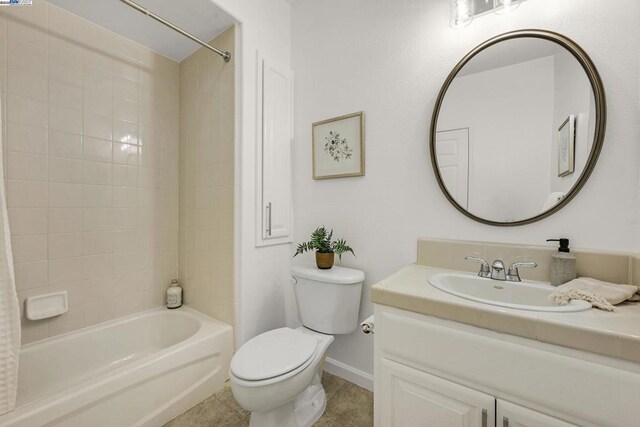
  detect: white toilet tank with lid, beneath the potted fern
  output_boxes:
[291,265,364,335]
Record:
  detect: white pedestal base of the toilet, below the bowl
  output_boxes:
[249,381,327,427]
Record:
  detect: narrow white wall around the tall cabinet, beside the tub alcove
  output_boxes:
[212,0,291,345]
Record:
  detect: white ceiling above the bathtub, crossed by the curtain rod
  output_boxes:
[48,0,235,62]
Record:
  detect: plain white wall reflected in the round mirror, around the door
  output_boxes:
[438,56,554,221]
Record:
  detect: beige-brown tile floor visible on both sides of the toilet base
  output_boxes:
[164,372,373,427]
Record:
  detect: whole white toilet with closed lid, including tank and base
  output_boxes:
[231,265,364,427]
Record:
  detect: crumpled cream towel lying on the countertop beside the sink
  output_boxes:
[549,277,638,311]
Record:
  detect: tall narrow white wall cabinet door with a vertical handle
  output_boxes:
[258,55,292,245]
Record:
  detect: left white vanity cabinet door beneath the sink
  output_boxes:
[375,358,495,427]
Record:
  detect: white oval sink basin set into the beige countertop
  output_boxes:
[429,273,591,312]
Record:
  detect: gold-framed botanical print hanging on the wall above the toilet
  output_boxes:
[312,111,364,179]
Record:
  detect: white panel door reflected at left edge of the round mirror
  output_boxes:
[436,128,469,209]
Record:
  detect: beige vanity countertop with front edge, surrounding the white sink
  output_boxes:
[371,264,640,363]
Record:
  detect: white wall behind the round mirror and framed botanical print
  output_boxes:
[292,0,640,380]
